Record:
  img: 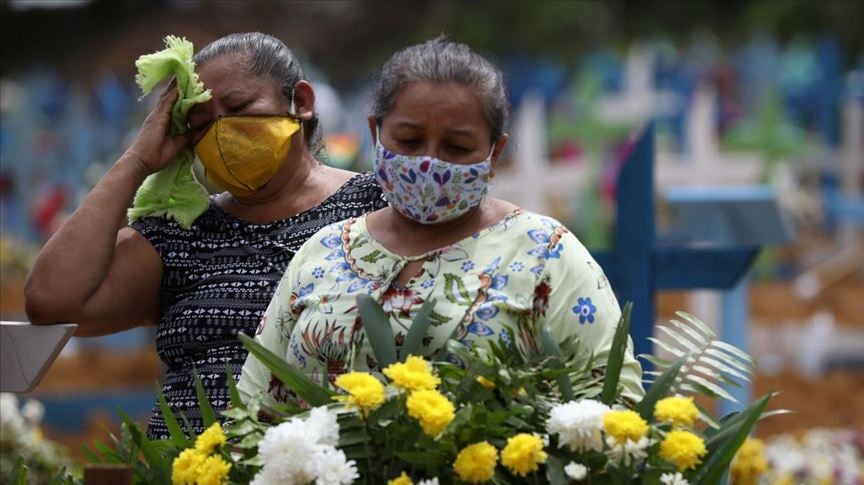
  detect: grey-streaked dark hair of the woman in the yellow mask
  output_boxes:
[192,32,326,161]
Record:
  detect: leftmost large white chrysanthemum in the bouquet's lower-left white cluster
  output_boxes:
[256,418,321,484]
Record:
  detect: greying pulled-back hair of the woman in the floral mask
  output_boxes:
[372,35,509,143]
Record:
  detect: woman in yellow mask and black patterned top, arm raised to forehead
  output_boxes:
[26,33,386,438]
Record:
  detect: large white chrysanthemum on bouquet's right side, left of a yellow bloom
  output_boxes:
[546,399,609,451]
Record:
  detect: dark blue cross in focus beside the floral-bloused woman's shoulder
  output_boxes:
[594,123,759,360]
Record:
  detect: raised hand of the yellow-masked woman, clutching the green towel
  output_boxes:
[124,81,189,174]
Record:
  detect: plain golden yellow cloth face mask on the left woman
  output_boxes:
[195,116,300,197]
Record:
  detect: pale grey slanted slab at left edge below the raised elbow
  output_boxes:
[0,321,78,393]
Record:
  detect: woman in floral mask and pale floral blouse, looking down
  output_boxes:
[239,39,643,404]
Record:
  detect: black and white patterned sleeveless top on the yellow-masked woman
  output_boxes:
[131,173,387,439]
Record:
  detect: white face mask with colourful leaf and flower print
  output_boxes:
[375,140,494,224]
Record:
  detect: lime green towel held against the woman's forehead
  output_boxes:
[127,35,211,229]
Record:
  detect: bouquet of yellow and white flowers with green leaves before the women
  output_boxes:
[82,296,771,484]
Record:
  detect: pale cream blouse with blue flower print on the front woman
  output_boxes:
[238,209,643,402]
